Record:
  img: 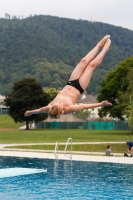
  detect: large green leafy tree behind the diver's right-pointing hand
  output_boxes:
[97,56,133,119]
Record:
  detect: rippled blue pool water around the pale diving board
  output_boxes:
[0,157,133,200]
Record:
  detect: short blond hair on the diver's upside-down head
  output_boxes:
[48,106,62,119]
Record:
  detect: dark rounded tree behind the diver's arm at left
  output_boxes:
[5,78,50,130]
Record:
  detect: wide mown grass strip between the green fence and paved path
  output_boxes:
[0,129,132,144]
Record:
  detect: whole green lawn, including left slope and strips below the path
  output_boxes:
[0,115,133,153]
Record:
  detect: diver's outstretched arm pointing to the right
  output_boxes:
[70,100,112,112]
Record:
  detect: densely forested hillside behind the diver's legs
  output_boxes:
[0,15,133,94]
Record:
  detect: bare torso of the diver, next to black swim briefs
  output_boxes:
[49,85,80,113]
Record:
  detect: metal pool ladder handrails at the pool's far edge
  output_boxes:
[54,138,72,160]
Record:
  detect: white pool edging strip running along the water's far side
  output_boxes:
[0,150,133,164]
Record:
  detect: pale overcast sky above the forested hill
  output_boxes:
[0,0,133,30]
